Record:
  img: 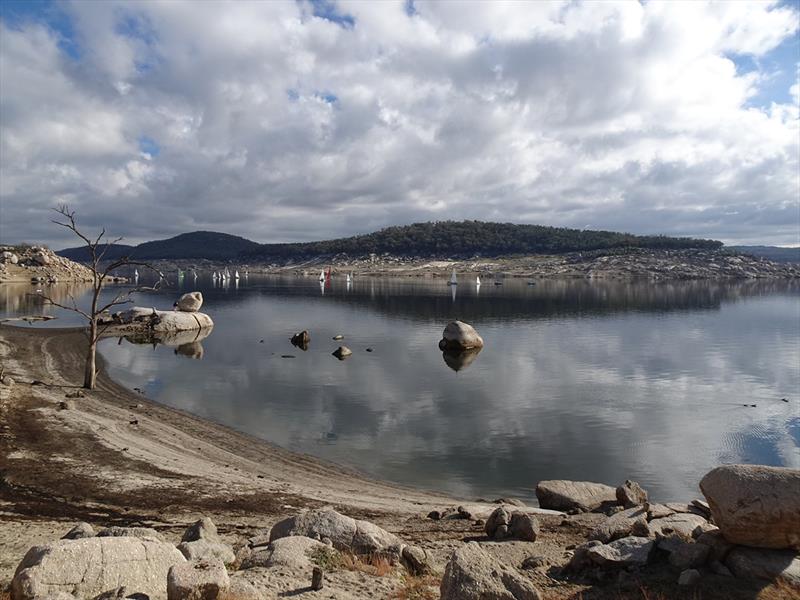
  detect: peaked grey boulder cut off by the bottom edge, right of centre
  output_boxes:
[440,542,541,600]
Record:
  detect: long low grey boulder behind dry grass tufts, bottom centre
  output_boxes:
[269,508,402,553]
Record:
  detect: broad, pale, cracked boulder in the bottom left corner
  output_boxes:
[11,537,186,600]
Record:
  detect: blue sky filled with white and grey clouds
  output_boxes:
[0,0,800,248]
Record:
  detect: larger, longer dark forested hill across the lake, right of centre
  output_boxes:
[243,221,722,262]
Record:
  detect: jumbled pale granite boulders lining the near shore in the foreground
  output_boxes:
[12,465,800,600]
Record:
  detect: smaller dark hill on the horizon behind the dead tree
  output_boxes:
[58,231,259,262]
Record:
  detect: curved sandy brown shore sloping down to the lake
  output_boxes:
[0,325,787,600]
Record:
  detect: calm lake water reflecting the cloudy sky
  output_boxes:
[0,275,800,501]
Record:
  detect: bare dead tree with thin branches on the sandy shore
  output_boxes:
[39,205,164,390]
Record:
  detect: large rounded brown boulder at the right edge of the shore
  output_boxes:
[700,465,800,550]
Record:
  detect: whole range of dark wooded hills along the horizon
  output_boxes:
[58,221,800,263]
